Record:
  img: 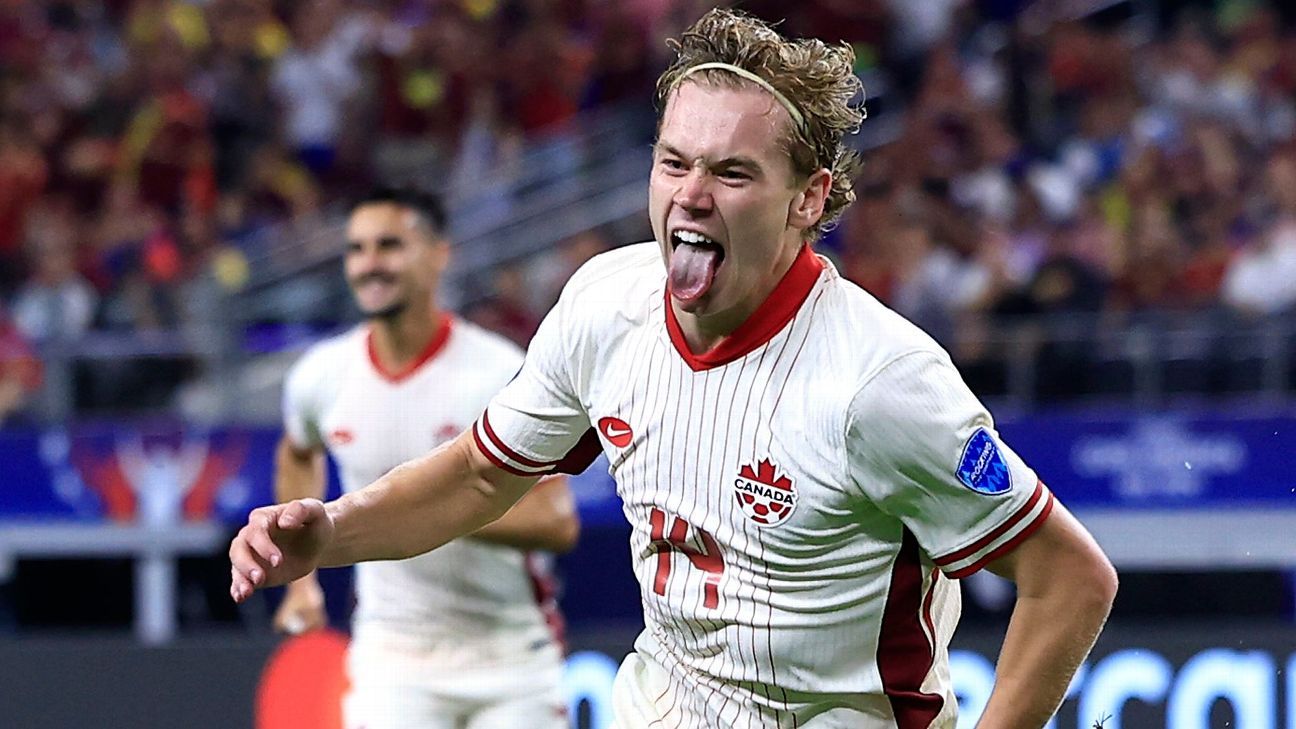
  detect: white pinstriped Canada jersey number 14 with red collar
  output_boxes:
[473,244,1052,729]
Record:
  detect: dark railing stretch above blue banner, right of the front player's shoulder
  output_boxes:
[945,309,1296,409]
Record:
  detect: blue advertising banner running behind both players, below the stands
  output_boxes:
[0,411,1296,525]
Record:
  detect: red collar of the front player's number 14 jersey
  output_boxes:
[666,245,823,372]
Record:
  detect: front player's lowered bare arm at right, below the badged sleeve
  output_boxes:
[977,503,1117,729]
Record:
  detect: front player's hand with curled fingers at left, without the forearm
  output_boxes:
[229,498,333,602]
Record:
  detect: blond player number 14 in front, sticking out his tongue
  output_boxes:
[229,10,1116,729]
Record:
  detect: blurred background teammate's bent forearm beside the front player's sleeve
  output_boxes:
[472,476,581,553]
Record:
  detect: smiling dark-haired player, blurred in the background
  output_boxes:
[275,184,578,729]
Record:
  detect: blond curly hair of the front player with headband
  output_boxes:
[656,9,864,240]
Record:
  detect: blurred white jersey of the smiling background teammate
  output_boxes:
[284,315,557,645]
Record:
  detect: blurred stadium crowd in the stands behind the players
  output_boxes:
[0,0,1296,420]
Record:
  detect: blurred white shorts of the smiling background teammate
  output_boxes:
[342,617,570,729]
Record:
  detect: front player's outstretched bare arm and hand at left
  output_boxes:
[229,432,537,602]
